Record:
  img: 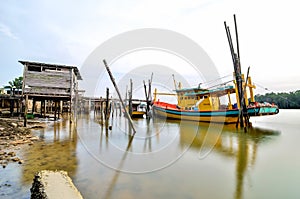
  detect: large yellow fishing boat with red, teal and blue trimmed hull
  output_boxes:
[152,81,279,124]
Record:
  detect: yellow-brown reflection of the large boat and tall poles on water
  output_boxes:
[179,121,280,199]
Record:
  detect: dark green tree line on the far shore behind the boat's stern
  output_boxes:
[255,90,300,109]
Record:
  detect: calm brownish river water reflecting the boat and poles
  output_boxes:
[0,110,300,199]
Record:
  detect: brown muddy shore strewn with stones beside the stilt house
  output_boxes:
[0,118,46,169]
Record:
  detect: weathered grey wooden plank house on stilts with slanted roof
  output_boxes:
[19,61,82,123]
